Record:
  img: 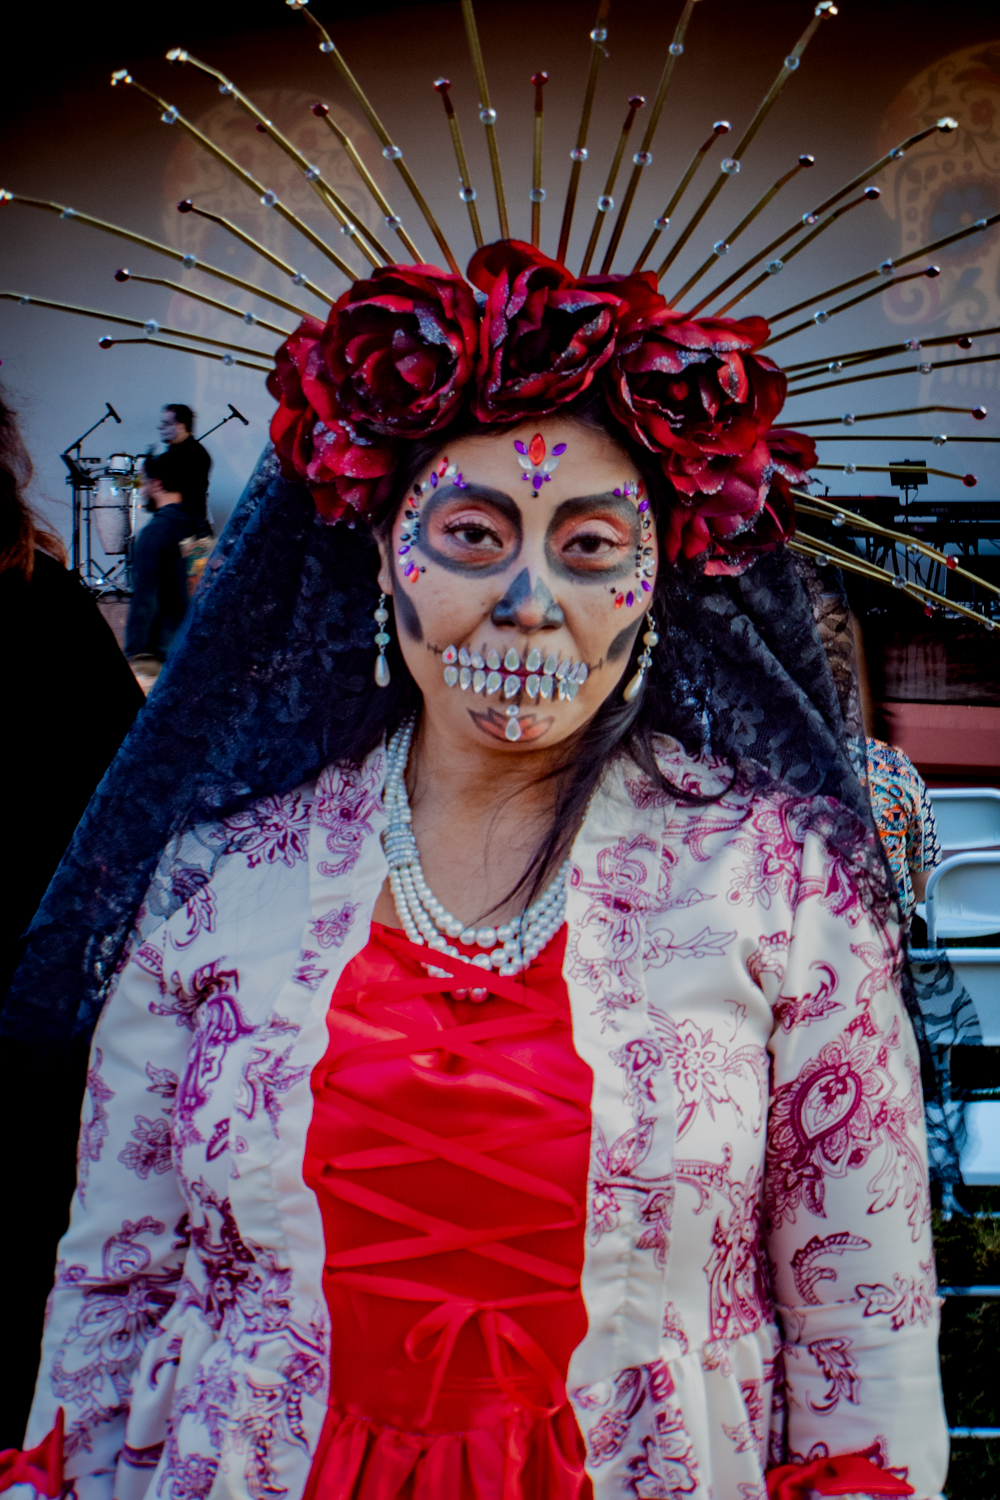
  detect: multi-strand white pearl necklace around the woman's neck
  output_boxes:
[382,717,570,975]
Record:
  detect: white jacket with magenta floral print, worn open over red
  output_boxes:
[27,741,948,1500]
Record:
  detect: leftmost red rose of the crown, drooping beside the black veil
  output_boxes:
[267,318,396,522]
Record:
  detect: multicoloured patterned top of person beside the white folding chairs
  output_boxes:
[865,735,942,927]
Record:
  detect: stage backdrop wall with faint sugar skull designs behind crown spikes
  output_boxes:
[0,0,1000,549]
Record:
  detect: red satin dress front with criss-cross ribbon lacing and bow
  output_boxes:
[304,923,592,1500]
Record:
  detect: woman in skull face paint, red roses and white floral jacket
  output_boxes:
[13,243,946,1500]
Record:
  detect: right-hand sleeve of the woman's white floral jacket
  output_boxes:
[765,837,948,1500]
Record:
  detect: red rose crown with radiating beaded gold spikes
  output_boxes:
[9,0,1000,629]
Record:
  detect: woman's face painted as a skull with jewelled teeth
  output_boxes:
[379,417,657,755]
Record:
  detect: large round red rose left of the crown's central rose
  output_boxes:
[316,266,480,438]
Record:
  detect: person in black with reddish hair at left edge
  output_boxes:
[0,378,142,1449]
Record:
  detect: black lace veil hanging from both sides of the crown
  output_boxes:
[0,449,919,1110]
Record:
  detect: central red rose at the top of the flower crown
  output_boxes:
[468,240,624,422]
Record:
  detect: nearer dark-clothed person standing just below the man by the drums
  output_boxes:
[124,456,211,662]
